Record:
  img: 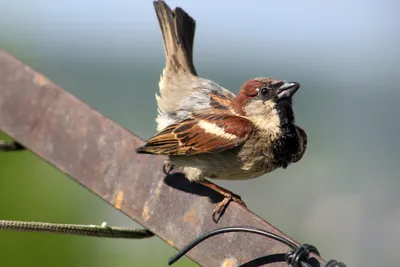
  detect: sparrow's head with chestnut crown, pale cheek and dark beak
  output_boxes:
[232,78,300,133]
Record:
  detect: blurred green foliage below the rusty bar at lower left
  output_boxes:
[0,134,193,266]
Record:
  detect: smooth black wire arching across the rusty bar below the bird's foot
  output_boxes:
[168,226,298,265]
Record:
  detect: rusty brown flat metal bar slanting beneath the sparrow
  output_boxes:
[0,50,323,266]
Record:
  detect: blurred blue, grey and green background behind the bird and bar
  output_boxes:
[0,0,400,267]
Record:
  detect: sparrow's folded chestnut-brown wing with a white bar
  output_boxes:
[136,113,253,155]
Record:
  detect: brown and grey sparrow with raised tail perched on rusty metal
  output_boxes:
[136,1,307,221]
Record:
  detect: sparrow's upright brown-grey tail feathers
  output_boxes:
[154,1,197,76]
